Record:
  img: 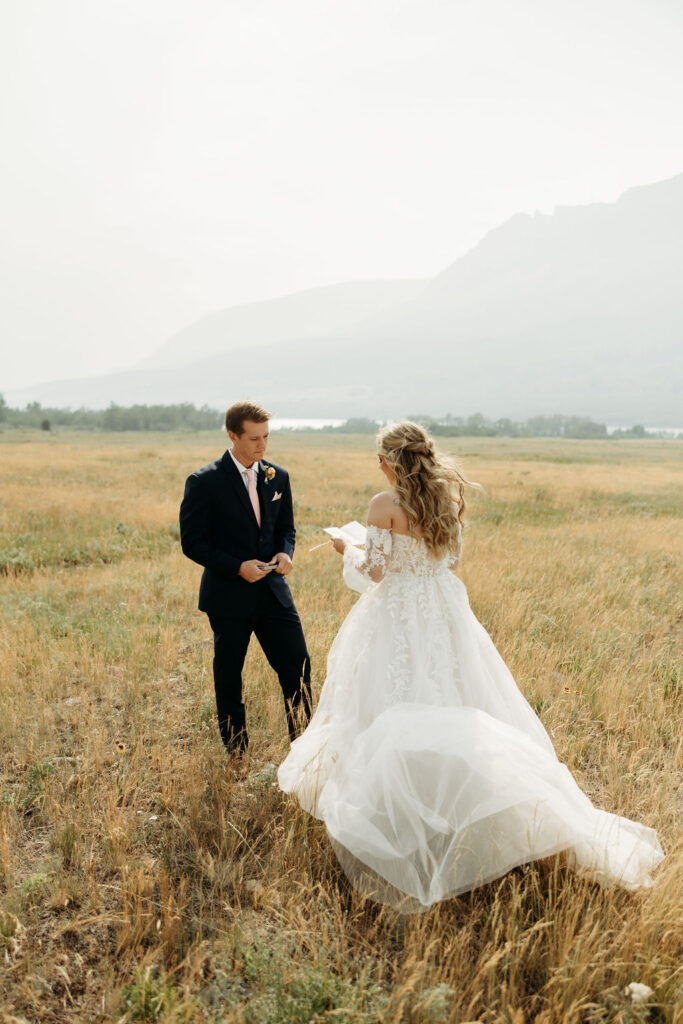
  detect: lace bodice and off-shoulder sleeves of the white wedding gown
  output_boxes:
[344,525,460,593]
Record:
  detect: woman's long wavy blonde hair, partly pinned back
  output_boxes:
[377,420,479,556]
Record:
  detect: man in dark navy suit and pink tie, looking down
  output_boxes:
[180,401,310,755]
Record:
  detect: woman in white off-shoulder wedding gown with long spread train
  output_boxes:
[278,422,664,911]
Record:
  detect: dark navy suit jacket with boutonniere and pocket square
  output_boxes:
[180,452,296,617]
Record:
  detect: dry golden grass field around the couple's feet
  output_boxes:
[0,431,683,1024]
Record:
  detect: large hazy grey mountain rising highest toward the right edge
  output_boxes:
[7,175,683,426]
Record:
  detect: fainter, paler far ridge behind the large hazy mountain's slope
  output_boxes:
[139,281,429,368]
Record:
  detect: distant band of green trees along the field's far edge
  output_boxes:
[0,394,683,438]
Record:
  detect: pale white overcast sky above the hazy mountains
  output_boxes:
[0,0,683,390]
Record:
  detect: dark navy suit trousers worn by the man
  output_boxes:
[209,581,311,752]
